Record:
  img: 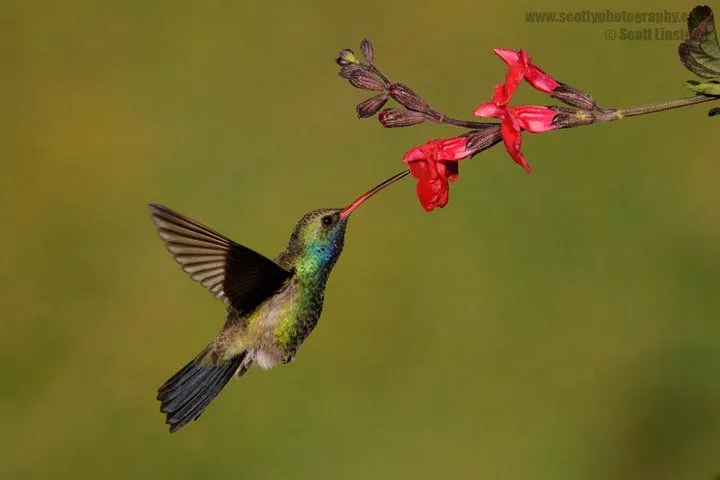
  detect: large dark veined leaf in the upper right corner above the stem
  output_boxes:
[678,5,720,78]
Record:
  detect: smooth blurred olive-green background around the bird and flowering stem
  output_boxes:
[0,0,720,480]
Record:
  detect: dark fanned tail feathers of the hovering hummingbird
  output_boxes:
[157,347,247,433]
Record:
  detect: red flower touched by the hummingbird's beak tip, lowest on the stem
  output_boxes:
[403,137,472,212]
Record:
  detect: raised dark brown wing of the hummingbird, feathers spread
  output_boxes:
[149,204,292,312]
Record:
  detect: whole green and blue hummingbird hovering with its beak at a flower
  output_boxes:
[149,170,409,433]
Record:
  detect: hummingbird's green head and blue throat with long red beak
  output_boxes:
[288,170,410,279]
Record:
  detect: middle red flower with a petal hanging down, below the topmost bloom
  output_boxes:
[473,85,558,173]
